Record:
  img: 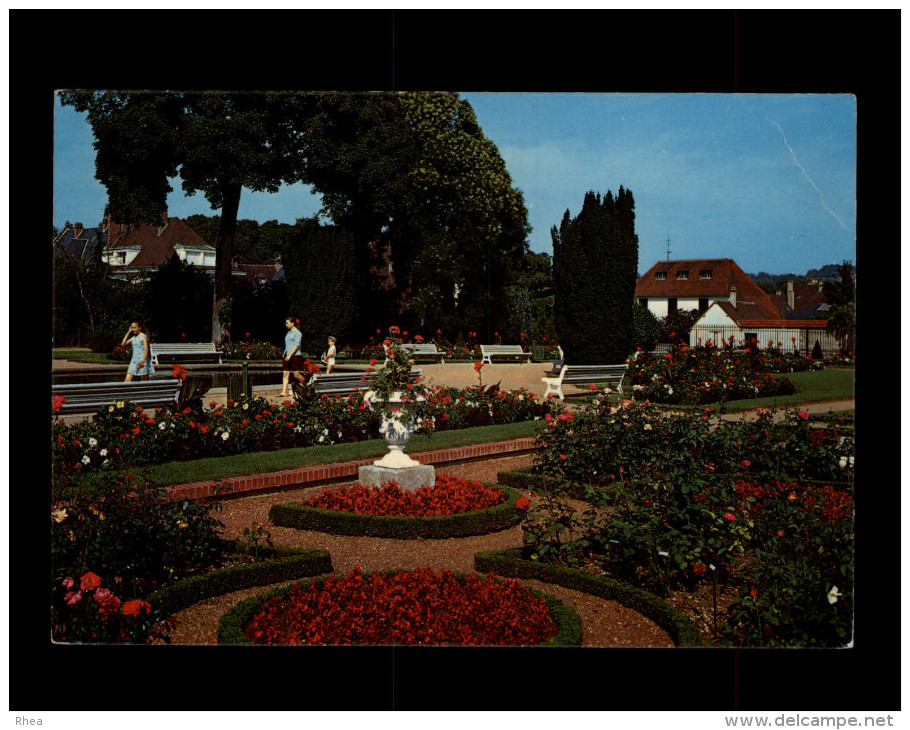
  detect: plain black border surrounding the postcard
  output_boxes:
[21,5,900,711]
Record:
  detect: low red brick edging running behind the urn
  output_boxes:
[165,436,536,500]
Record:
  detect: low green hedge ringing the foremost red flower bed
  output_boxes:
[218,570,582,646]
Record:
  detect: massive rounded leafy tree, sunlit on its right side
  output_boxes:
[306,94,530,338]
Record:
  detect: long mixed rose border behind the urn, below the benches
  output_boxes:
[51,387,549,484]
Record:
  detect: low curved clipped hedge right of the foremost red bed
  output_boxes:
[474,548,708,646]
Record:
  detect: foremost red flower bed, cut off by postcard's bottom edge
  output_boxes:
[245,566,557,645]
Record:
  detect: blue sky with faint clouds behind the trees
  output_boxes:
[53,93,857,274]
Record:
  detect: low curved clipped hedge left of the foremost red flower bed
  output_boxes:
[148,543,332,616]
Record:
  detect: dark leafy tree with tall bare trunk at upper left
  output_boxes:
[61,91,313,338]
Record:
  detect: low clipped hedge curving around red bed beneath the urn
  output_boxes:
[269,484,525,540]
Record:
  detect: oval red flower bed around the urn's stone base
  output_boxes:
[303,474,505,517]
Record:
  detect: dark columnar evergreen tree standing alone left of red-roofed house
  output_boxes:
[551,187,638,365]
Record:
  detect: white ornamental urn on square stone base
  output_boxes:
[360,391,436,491]
